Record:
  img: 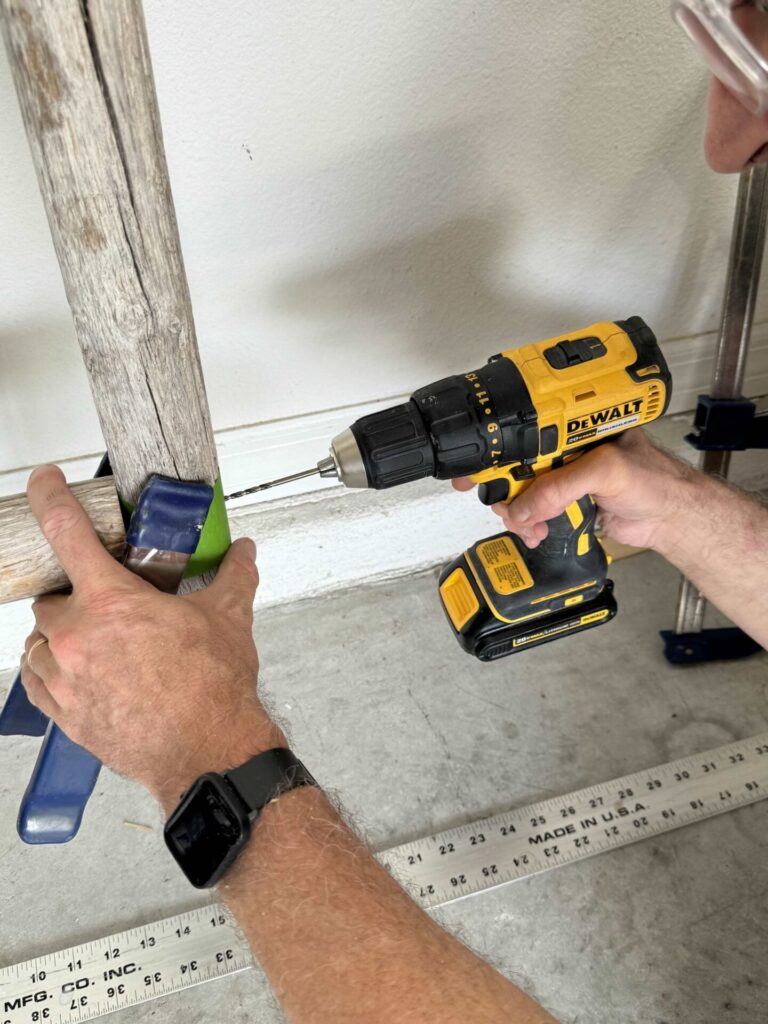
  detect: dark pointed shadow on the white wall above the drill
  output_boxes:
[270,207,581,383]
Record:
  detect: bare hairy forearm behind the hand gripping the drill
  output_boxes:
[654,471,768,647]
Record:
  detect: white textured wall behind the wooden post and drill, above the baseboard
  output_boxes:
[0,0,766,482]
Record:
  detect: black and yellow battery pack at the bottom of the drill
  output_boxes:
[439,532,616,662]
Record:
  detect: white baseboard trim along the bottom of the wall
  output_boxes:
[0,325,768,669]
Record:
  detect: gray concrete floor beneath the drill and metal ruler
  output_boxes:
[0,554,768,1024]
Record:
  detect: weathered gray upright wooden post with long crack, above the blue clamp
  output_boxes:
[0,0,218,503]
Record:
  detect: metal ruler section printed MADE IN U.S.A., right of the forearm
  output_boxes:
[384,735,768,906]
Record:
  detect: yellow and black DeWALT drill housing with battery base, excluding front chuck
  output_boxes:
[430,317,671,660]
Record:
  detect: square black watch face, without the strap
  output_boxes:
[165,775,250,889]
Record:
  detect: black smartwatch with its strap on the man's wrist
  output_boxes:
[164,748,317,889]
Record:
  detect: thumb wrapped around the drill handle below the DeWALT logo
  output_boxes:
[503,444,623,529]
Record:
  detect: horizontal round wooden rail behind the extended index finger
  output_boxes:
[0,476,125,604]
